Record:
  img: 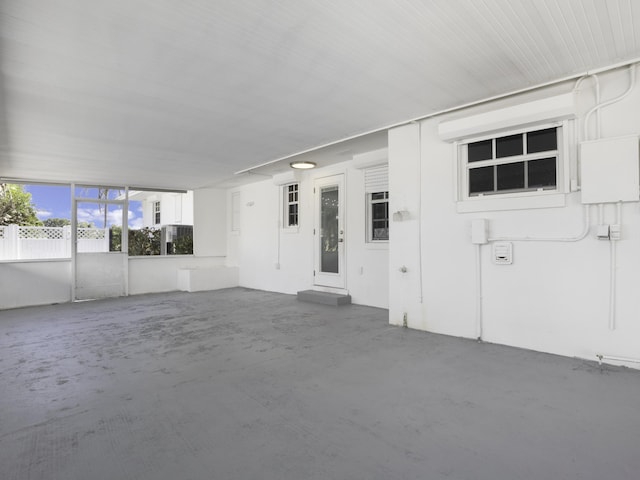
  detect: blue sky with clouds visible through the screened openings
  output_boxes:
[24,185,142,228]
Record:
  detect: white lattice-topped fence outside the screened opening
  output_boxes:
[0,225,109,260]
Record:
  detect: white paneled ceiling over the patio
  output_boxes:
[0,0,640,189]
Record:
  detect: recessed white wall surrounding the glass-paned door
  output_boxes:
[227,158,389,308]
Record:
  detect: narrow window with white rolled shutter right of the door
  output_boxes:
[364,164,389,243]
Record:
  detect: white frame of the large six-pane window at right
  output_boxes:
[455,120,570,213]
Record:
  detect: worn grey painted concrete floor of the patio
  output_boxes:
[0,288,640,480]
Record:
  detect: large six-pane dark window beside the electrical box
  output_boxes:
[461,125,562,198]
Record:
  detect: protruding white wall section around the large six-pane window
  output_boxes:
[389,70,640,368]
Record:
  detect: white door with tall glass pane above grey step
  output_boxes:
[314,175,345,288]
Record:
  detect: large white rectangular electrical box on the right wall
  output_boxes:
[580,135,640,203]
